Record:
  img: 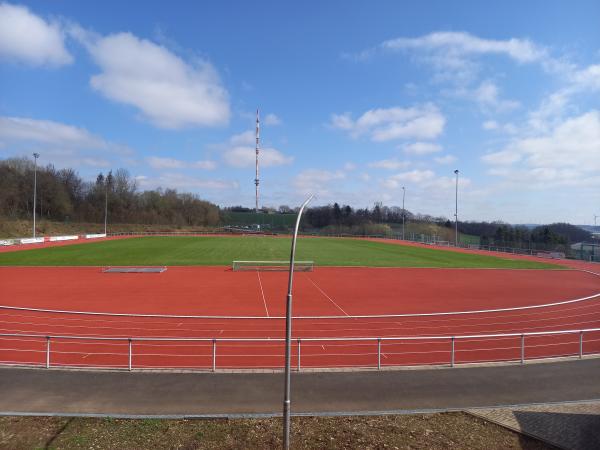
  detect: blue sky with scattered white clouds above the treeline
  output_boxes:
[0,1,600,223]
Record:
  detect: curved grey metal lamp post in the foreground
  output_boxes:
[283,194,314,450]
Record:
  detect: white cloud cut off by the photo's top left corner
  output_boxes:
[0,3,73,66]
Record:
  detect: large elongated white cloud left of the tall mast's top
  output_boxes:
[78,31,230,129]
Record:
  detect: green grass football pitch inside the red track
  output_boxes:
[0,236,558,269]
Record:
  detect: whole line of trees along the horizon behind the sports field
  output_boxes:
[0,158,592,248]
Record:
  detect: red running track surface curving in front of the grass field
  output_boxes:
[0,267,600,369]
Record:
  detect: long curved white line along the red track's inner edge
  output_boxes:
[0,269,600,320]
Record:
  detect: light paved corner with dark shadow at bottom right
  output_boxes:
[468,401,600,450]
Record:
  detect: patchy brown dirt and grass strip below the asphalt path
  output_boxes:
[0,413,553,450]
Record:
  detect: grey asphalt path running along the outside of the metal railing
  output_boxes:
[0,358,600,417]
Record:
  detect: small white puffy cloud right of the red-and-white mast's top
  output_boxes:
[330,104,446,142]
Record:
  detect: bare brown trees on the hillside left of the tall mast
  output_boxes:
[0,158,219,226]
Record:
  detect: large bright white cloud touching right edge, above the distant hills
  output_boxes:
[482,110,600,188]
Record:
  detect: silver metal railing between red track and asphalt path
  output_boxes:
[0,328,600,372]
